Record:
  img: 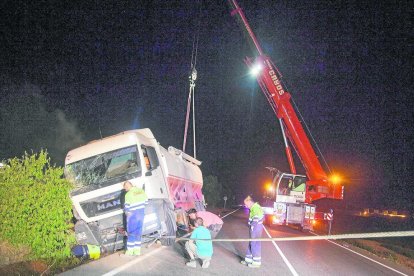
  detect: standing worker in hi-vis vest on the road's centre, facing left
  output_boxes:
[241,196,264,268]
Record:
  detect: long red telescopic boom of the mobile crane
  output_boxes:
[228,0,343,203]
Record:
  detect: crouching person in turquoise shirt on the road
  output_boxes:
[185,218,213,268]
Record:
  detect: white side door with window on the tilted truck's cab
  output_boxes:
[141,145,168,198]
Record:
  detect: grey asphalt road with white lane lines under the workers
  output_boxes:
[62,209,414,276]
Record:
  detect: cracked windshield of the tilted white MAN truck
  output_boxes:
[65,146,141,191]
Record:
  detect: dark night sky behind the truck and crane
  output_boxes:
[0,0,414,208]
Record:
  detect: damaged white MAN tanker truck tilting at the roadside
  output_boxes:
[65,128,204,253]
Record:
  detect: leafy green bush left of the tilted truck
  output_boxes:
[0,151,75,260]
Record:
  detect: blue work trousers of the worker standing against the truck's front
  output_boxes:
[127,208,145,250]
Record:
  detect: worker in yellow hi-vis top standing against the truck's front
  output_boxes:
[124,181,148,256]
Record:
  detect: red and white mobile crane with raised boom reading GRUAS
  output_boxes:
[227,0,344,231]
